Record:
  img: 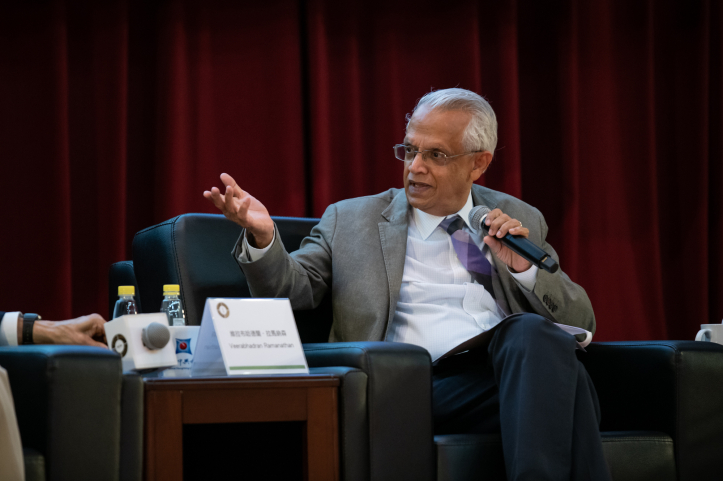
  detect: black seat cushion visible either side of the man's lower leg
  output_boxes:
[434,431,676,481]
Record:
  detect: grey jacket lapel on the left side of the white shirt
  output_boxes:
[373,190,409,341]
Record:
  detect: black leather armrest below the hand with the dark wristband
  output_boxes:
[0,346,122,480]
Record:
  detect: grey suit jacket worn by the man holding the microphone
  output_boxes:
[234,184,595,342]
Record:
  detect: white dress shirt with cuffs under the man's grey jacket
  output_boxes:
[238,190,538,360]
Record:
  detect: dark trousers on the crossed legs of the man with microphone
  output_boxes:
[433,314,610,480]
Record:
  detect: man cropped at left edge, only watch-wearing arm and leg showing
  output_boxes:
[0,311,107,481]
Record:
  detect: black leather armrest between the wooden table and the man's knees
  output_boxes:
[304,342,434,480]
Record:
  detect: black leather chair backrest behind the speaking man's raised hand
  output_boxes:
[133,214,332,343]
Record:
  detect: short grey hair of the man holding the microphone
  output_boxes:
[407,88,497,153]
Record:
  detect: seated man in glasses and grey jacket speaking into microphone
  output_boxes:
[204,89,609,480]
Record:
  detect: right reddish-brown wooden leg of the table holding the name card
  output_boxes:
[305,388,339,481]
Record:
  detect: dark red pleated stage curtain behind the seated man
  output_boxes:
[0,0,723,340]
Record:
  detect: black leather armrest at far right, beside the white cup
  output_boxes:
[579,341,723,481]
